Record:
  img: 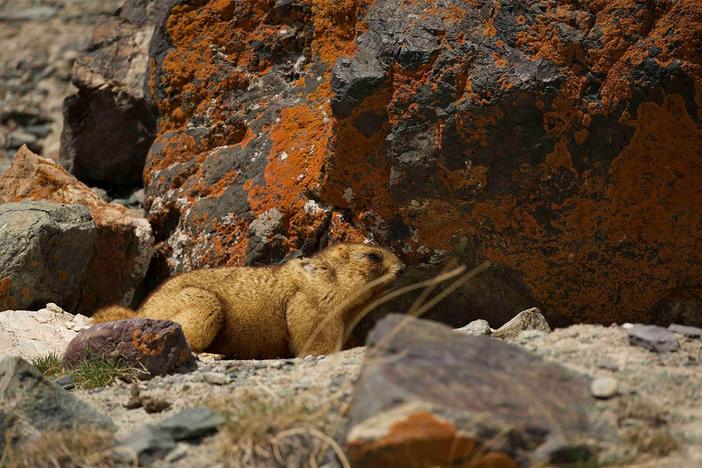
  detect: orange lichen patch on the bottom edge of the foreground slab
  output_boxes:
[348,411,517,468]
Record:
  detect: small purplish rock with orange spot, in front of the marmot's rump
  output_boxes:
[62,318,193,376]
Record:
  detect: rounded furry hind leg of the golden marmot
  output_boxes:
[148,288,224,352]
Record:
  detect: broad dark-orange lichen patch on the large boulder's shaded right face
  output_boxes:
[420,95,702,322]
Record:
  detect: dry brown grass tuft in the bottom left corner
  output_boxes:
[0,428,114,468]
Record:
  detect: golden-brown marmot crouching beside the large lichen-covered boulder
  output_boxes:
[93,243,404,359]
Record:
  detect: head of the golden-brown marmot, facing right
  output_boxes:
[309,243,405,304]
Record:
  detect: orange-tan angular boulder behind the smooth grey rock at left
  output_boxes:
[0,148,153,315]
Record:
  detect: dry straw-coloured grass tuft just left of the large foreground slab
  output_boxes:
[210,391,349,467]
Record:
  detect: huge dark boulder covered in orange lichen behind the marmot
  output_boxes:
[145,0,702,326]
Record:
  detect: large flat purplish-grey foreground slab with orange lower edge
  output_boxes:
[346,315,597,467]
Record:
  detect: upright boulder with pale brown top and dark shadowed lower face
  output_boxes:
[60,0,162,189]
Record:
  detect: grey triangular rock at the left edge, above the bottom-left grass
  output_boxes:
[0,356,114,448]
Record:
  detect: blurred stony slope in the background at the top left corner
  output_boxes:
[0,0,122,168]
